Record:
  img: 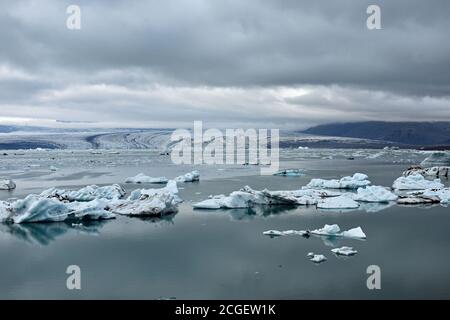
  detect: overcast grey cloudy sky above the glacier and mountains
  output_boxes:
[0,0,450,129]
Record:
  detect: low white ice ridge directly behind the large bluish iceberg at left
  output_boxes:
[41,184,125,201]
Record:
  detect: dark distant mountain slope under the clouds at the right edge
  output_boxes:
[302,121,450,146]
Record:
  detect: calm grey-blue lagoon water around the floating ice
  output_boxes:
[0,150,450,299]
